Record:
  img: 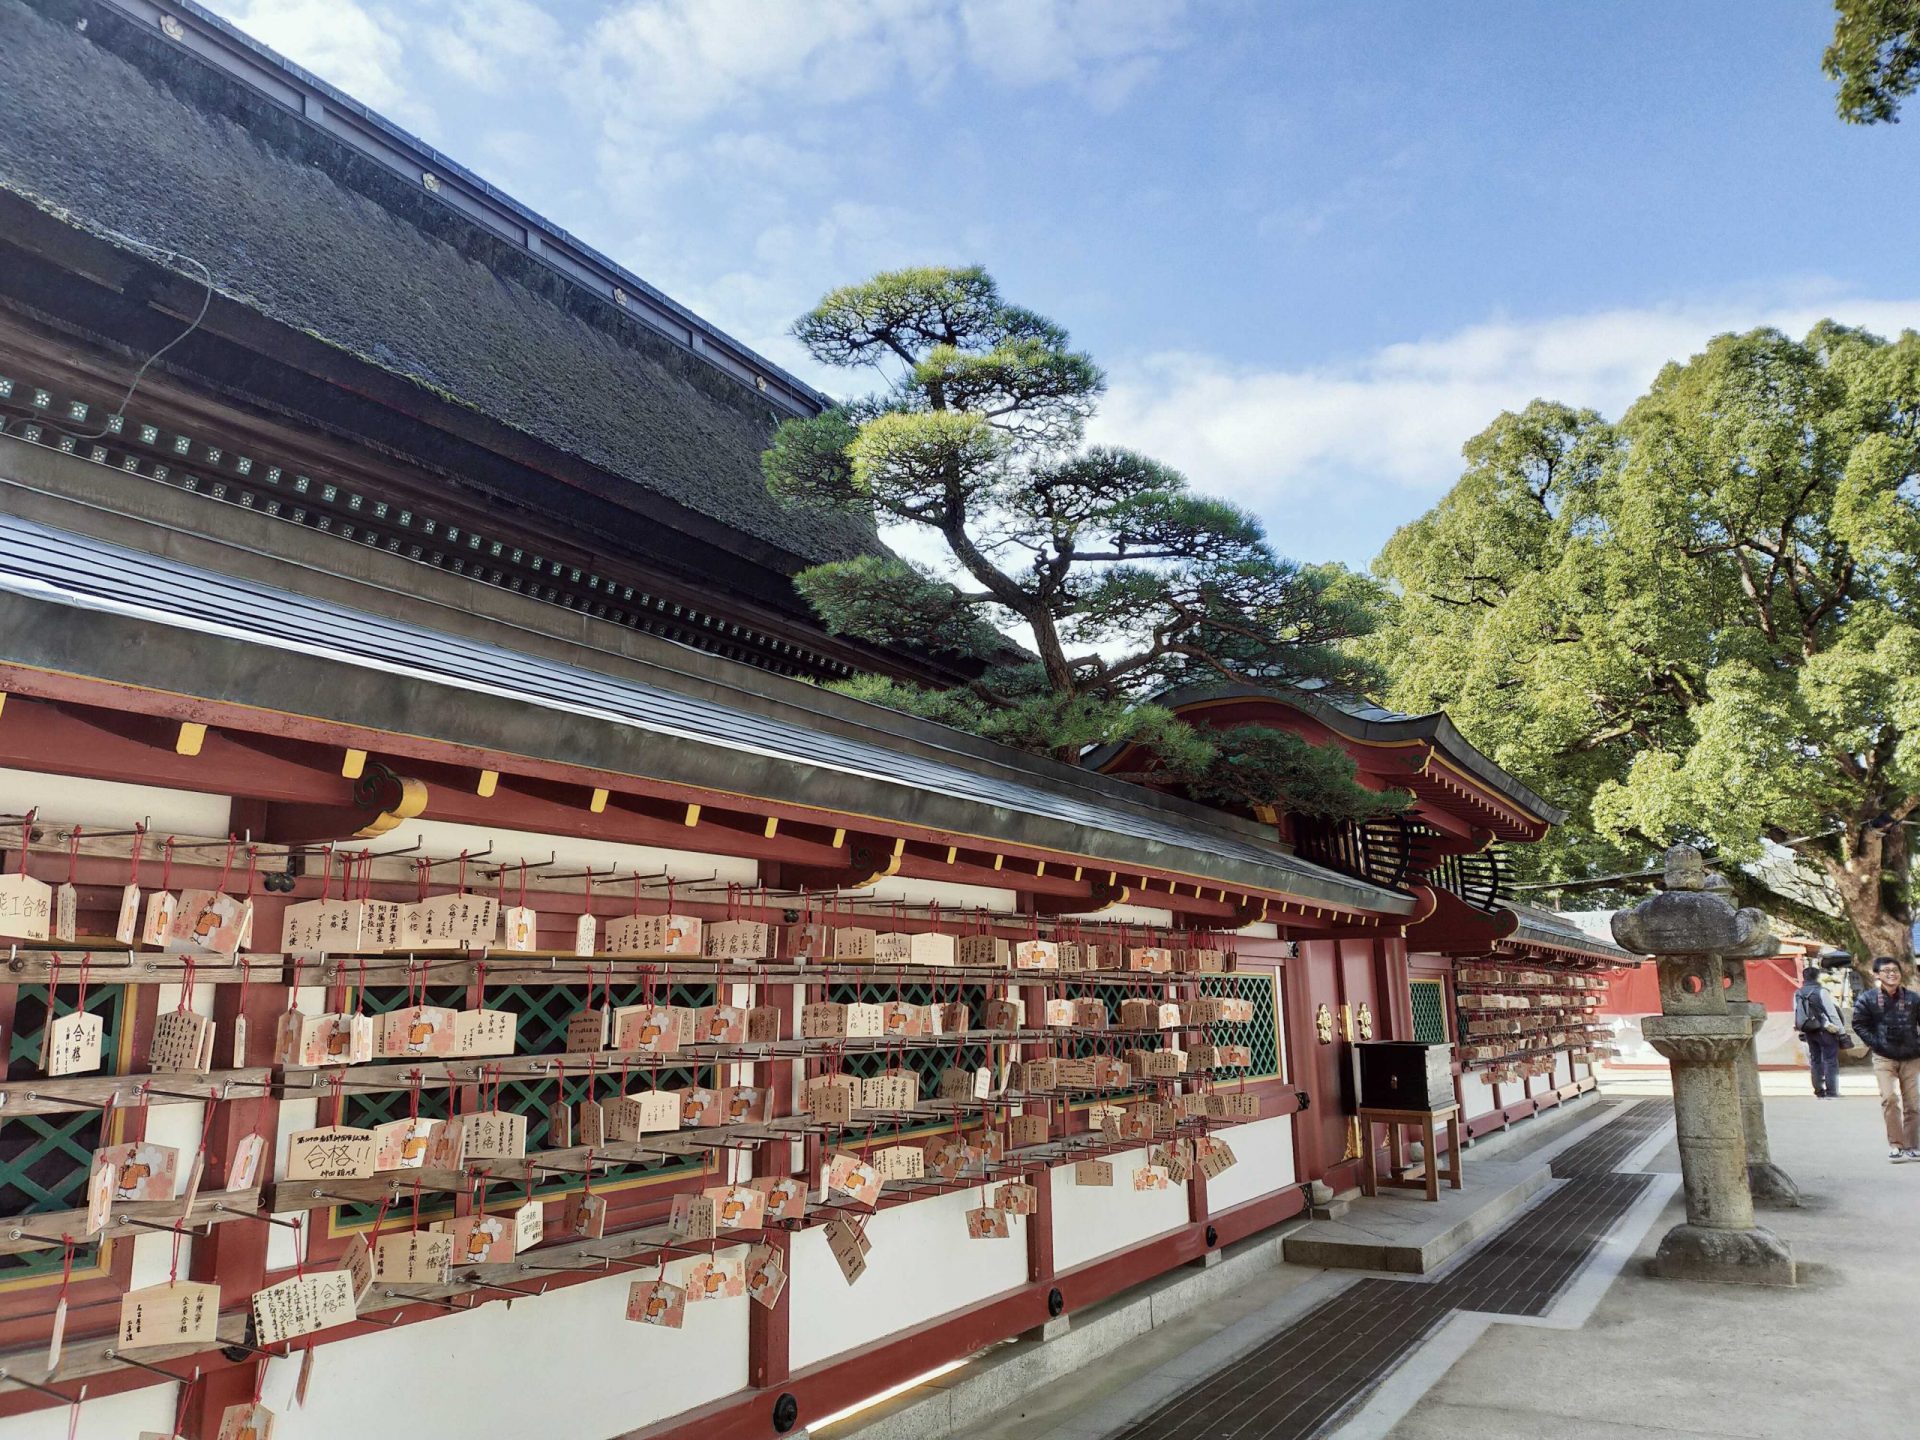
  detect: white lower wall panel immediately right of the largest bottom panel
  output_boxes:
[787,1188,1027,1369]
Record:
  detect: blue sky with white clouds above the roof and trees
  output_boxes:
[198,0,1920,564]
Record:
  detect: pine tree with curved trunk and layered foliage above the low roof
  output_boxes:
[762,269,1404,816]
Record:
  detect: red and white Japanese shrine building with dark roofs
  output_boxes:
[0,0,1632,1440]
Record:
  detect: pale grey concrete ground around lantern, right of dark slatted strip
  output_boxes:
[1374,1077,1920,1440]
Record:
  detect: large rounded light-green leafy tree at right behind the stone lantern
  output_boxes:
[1369,332,1920,975]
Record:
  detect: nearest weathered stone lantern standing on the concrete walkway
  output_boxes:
[1613,845,1795,1284]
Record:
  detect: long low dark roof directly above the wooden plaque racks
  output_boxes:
[0,515,1411,914]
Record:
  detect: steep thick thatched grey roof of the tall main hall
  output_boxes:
[0,0,876,561]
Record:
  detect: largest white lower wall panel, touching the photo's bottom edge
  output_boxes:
[266,1250,753,1440]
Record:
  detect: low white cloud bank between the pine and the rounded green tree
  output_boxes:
[1092,298,1920,563]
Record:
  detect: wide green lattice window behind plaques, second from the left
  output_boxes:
[336,981,718,1229]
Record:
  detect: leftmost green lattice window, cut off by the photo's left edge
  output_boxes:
[0,985,127,1281]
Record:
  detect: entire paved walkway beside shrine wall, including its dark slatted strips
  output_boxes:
[929,1073,1920,1440]
